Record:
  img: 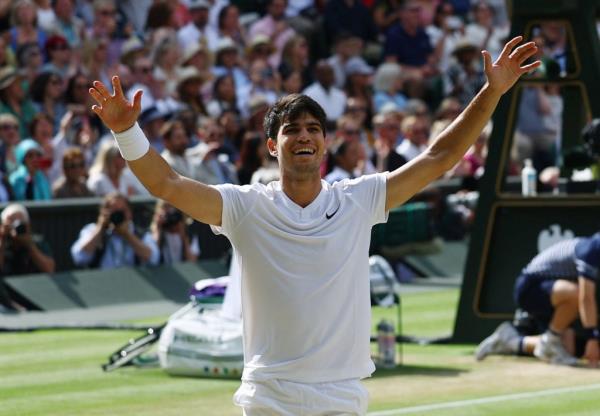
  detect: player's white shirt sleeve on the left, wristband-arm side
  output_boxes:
[211,183,264,237]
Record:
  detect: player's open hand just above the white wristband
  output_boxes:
[89,75,142,133]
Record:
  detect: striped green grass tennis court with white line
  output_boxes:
[0,289,600,416]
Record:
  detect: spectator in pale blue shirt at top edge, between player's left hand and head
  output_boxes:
[177,0,219,51]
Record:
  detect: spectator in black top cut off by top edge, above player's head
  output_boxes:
[323,0,377,45]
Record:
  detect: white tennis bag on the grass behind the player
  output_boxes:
[158,284,244,378]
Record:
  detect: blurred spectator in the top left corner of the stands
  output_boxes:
[9,0,46,52]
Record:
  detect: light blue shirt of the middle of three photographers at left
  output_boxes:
[71,223,160,269]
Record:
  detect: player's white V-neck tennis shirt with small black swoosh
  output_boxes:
[213,174,387,383]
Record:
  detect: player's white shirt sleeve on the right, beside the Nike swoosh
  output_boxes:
[340,172,388,225]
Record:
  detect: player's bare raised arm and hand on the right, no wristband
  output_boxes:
[385,36,540,210]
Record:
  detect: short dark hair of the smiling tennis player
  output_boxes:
[263,94,327,140]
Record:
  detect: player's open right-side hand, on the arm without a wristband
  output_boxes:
[482,36,541,94]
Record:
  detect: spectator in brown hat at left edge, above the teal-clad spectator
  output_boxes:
[0,66,36,137]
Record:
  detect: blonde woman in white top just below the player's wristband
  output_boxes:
[87,140,137,196]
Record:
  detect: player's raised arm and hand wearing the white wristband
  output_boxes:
[90,76,223,225]
